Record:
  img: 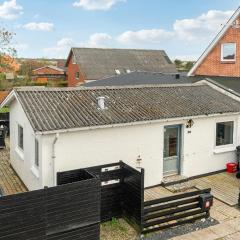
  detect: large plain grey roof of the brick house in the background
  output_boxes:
[67,48,177,80]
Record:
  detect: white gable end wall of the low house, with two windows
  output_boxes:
[10,101,42,190]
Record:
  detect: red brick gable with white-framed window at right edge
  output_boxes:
[188,8,240,77]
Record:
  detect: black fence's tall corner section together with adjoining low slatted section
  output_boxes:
[57,162,213,234]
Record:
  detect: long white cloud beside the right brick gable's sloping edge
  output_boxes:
[117,10,233,44]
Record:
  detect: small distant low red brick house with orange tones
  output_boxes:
[32,66,66,83]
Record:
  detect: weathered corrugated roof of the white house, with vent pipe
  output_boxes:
[11,84,240,132]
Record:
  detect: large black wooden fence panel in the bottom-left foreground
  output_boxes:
[0,169,100,240]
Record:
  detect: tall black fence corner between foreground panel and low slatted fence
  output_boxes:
[57,162,144,230]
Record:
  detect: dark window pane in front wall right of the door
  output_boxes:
[216,122,234,146]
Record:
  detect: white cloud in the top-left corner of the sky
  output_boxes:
[0,0,23,20]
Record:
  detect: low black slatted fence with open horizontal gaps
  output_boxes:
[142,189,211,234]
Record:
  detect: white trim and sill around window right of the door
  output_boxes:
[213,119,237,154]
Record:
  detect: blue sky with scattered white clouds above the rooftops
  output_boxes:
[0,0,239,60]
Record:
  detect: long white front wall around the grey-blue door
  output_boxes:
[42,115,240,187]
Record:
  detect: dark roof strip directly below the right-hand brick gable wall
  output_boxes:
[189,76,240,96]
